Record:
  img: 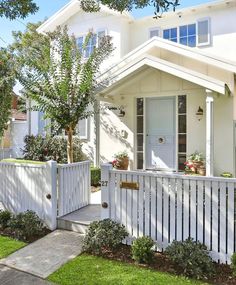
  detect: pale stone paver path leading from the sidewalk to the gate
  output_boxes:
[0,230,83,278]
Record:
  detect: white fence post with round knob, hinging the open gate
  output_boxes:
[44,160,57,230]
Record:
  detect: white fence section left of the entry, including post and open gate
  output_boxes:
[0,161,90,230]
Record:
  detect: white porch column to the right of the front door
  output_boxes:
[206,89,214,176]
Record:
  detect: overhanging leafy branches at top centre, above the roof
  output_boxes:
[80,0,179,18]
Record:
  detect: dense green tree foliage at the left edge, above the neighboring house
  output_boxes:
[0,48,15,139]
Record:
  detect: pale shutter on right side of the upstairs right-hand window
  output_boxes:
[197,18,210,46]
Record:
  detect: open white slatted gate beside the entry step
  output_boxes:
[58,161,90,217]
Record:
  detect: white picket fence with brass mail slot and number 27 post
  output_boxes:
[102,165,236,263]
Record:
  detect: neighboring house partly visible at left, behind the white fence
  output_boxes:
[0,94,28,159]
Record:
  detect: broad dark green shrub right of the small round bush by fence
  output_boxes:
[165,238,214,279]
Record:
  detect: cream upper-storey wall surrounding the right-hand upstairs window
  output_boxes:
[130,1,236,61]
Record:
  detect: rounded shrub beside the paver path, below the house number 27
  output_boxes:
[83,219,128,254]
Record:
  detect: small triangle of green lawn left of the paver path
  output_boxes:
[0,236,26,259]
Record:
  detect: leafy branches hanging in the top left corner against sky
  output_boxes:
[0,0,38,20]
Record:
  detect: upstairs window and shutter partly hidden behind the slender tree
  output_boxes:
[77,30,106,58]
